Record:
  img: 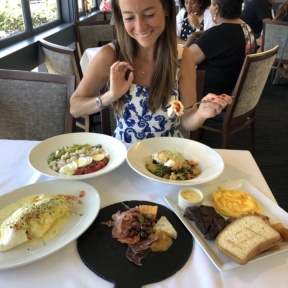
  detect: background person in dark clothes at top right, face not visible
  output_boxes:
[241,0,277,51]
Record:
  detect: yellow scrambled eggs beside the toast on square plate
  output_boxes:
[211,186,262,218]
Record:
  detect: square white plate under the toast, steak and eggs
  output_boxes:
[165,179,288,270]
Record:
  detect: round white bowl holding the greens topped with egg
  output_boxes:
[127,137,224,186]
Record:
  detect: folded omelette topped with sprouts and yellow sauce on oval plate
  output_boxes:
[0,194,74,251]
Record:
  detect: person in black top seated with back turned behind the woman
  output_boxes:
[189,0,255,95]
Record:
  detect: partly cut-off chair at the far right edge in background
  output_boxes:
[261,19,288,80]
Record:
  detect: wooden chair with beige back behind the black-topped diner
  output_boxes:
[197,45,279,154]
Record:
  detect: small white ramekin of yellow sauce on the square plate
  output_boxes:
[178,187,203,211]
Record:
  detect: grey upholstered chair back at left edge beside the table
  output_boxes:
[0,69,75,140]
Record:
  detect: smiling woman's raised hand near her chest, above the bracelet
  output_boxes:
[109,61,134,102]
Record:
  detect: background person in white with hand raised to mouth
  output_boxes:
[176,0,212,45]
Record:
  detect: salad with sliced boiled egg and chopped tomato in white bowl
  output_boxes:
[48,144,110,176]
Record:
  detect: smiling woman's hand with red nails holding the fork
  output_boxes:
[197,93,232,119]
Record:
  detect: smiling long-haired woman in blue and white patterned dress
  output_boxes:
[70,0,232,143]
